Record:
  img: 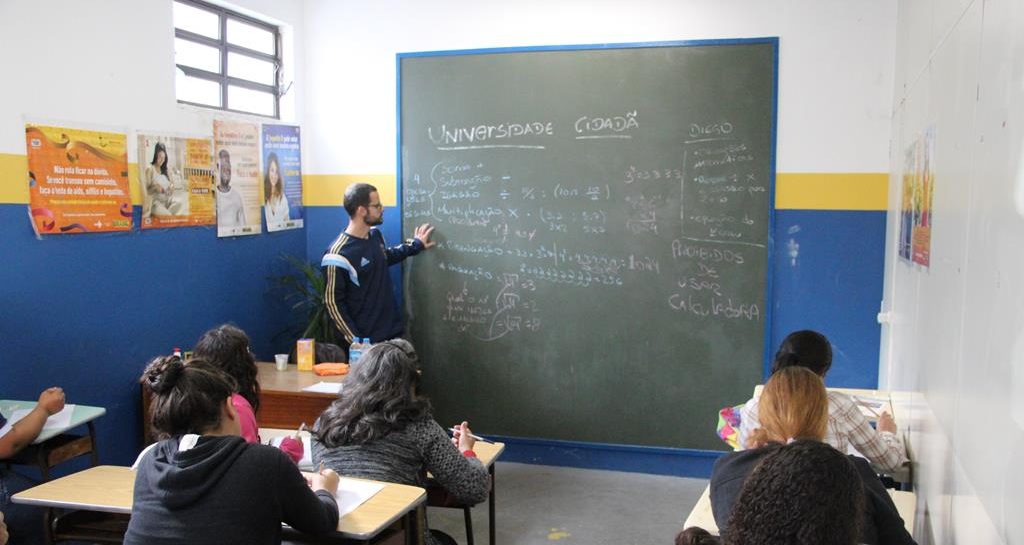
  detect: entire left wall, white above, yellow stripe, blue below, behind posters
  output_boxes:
[0,0,306,464]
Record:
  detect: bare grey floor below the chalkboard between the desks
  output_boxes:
[7,462,708,545]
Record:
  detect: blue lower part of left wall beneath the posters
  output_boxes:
[0,205,306,465]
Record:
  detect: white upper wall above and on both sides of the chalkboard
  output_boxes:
[303,0,896,173]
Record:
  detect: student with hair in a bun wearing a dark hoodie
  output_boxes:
[124,357,338,545]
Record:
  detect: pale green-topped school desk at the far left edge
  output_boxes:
[0,400,106,480]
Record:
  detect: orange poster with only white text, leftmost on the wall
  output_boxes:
[25,124,132,235]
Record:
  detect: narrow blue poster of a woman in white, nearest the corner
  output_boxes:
[263,125,303,230]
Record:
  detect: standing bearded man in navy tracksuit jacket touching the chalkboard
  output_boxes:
[321,183,437,344]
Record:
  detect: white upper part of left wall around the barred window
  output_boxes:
[0,0,305,155]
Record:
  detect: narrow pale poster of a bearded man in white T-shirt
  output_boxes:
[213,120,262,237]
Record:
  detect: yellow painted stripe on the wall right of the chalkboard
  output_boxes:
[775,172,889,211]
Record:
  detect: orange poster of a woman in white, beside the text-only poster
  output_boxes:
[138,134,216,228]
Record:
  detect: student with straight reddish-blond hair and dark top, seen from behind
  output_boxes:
[711,367,914,545]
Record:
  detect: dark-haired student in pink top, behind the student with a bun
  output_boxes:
[193,324,303,463]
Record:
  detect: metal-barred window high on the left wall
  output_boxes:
[173,0,282,118]
